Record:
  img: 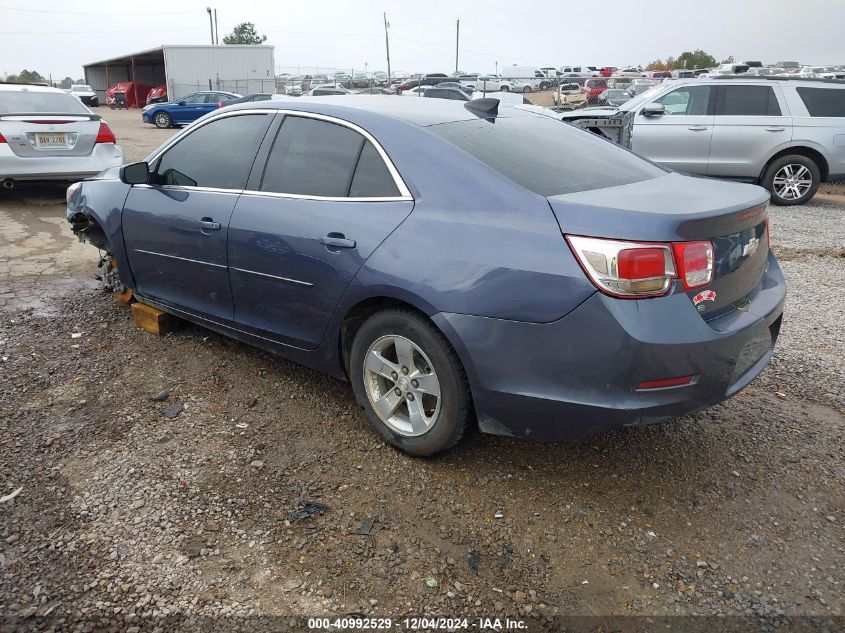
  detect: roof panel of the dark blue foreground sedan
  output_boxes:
[226,94,538,127]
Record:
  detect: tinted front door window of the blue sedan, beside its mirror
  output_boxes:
[155,114,269,189]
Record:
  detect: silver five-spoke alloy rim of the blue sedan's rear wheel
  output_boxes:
[363,335,441,437]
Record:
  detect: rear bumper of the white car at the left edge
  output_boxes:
[0,143,123,180]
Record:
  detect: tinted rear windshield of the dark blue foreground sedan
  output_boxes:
[427,116,665,196]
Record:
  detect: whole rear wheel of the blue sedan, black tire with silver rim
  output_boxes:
[349,309,472,457]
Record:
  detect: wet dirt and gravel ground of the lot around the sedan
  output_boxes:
[0,106,845,633]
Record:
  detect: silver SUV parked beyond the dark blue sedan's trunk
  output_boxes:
[563,78,845,205]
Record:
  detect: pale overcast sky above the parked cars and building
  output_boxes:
[0,0,845,80]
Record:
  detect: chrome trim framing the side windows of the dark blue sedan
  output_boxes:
[146,108,414,202]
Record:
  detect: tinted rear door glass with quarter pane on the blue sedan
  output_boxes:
[261,116,398,198]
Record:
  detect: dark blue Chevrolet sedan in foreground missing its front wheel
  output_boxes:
[67,96,785,456]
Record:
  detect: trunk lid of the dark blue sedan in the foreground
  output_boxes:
[548,174,769,320]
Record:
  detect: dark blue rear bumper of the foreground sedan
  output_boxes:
[435,255,786,440]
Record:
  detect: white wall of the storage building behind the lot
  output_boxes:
[164,45,276,99]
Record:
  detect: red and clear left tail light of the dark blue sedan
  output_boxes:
[565,235,713,299]
